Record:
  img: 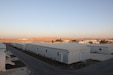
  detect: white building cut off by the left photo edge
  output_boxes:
[0,43,6,71]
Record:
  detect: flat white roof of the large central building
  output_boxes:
[30,43,88,51]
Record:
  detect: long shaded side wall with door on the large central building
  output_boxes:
[26,44,68,63]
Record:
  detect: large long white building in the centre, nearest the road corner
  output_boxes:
[25,43,90,64]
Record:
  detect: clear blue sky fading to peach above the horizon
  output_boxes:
[0,0,113,38]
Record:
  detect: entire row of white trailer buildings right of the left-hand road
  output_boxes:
[11,43,113,64]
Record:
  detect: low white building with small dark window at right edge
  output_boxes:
[88,44,113,54]
